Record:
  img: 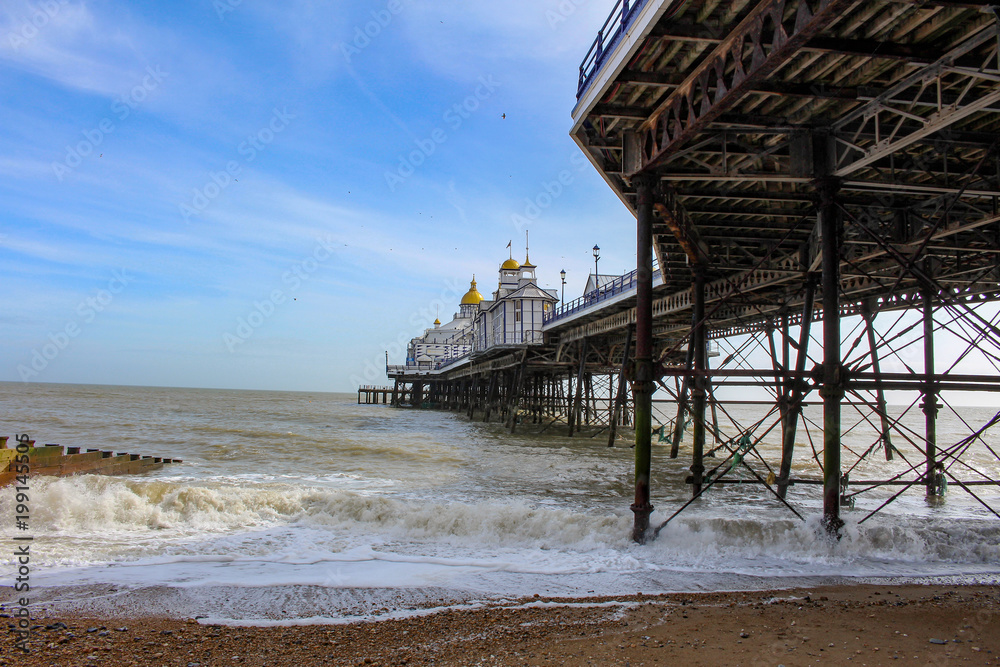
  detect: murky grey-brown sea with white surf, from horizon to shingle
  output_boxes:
[0,383,1000,623]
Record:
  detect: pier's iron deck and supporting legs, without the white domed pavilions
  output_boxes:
[380,0,1000,542]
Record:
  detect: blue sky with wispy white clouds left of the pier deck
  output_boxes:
[0,0,635,391]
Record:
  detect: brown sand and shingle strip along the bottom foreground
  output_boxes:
[0,585,1000,667]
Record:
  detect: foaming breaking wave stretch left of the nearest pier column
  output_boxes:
[0,476,628,546]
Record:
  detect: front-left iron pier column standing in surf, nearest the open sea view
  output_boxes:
[631,174,656,544]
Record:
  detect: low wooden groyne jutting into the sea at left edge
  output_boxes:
[0,436,182,487]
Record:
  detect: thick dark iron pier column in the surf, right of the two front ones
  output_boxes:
[817,177,844,535]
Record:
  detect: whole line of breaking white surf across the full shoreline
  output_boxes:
[0,476,1000,574]
